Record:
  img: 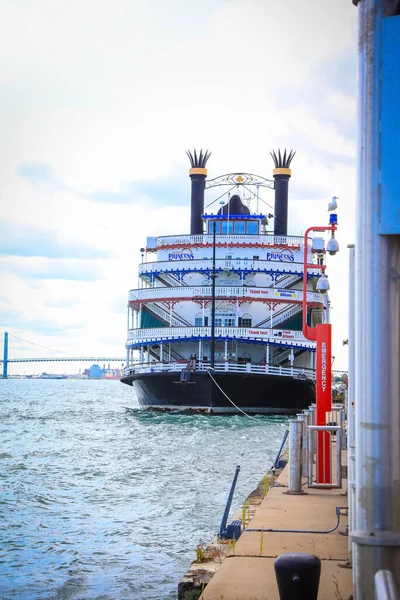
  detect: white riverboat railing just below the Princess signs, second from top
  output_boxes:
[139,257,321,276]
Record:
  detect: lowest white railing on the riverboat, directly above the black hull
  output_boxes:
[124,361,315,380]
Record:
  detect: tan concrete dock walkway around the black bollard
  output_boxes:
[201,467,353,600]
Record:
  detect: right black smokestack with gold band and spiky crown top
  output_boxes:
[271,150,296,235]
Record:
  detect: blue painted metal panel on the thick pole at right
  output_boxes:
[379,16,400,234]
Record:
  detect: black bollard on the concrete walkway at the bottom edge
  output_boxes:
[274,552,321,600]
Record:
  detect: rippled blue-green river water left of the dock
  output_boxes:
[0,380,287,600]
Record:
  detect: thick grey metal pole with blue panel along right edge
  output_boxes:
[352,0,400,600]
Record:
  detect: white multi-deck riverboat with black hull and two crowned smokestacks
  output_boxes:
[121,151,329,414]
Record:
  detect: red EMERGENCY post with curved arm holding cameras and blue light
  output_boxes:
[303,214,339,484]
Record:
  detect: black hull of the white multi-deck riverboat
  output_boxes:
[121,372,315,414]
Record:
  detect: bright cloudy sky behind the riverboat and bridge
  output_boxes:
[0,0,357,373]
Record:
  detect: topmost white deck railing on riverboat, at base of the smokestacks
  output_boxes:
[153,234,311,249]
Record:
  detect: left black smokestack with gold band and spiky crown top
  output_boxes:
[186,150,211,235]
